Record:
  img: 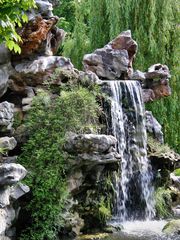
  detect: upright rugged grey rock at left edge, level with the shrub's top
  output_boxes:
[0,101,14,130]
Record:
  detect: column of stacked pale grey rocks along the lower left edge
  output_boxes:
[0,137,29,240]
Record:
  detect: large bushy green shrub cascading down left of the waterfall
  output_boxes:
[18,87,99,240]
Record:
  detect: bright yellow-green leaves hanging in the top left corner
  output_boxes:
[0,0,36,53]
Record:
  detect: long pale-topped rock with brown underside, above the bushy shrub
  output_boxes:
[11,56,73,86]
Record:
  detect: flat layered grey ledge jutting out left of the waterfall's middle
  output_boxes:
[64,134,121,169]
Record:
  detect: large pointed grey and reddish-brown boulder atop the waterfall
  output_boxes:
[83,30,137,79]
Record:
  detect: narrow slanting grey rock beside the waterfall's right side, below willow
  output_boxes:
[145,111,164,143]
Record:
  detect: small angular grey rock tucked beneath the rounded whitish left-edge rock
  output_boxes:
[10,183,30,200]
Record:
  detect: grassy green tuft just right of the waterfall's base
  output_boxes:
[155,187,172,218]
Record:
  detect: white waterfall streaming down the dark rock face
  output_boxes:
[108,81,155,222]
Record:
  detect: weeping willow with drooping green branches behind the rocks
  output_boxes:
[59,0,180,151]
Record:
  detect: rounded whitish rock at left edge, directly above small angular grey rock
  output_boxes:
[0,163,27,186]
